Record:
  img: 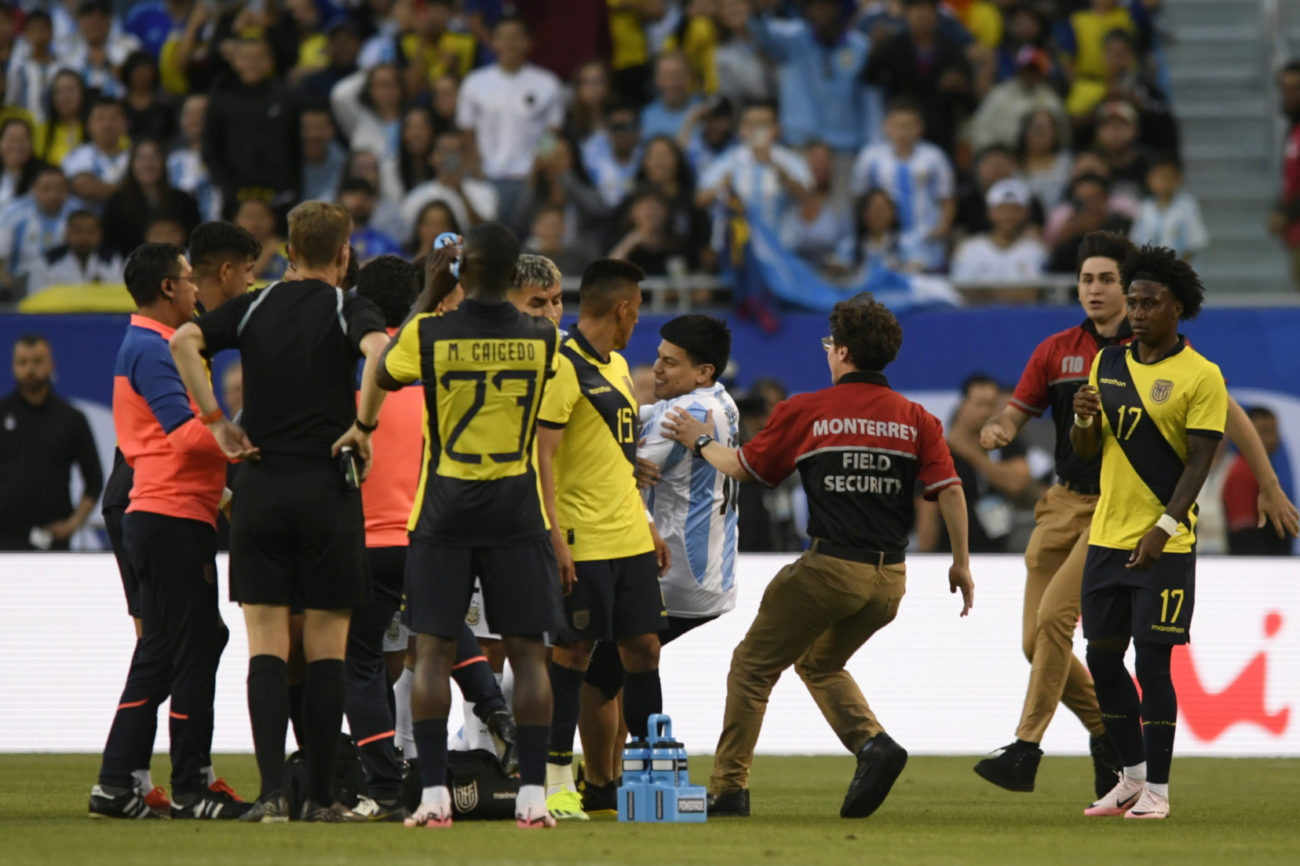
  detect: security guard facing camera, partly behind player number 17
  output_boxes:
[975,231,1297,797]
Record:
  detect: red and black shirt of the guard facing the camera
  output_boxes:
[1011,319,1132,488]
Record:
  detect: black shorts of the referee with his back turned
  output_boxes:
[230,455,371,610]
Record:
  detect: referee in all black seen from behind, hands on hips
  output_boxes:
[172,202,389,822]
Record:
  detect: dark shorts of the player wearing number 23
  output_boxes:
[402,538,560,638]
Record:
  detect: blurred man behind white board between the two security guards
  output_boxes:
[917,371,1031,553]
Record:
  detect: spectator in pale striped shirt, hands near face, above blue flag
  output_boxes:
[696,103,813,228]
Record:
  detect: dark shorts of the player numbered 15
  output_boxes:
[555,550,668,645]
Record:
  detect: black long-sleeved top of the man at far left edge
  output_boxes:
[0,391,104,550]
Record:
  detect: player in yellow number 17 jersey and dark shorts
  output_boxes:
[1070,240,1227,819]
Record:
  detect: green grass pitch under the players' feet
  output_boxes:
[0,754,1300,866]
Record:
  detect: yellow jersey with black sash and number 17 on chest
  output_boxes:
[1088,338,1227,553]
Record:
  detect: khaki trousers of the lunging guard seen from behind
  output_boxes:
[709,551,906,793]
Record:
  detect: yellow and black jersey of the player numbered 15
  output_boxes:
[537,328,654,562]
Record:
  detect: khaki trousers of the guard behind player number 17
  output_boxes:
[1015,484,1105,742]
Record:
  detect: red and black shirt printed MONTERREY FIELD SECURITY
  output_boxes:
[740,371,961,553]
